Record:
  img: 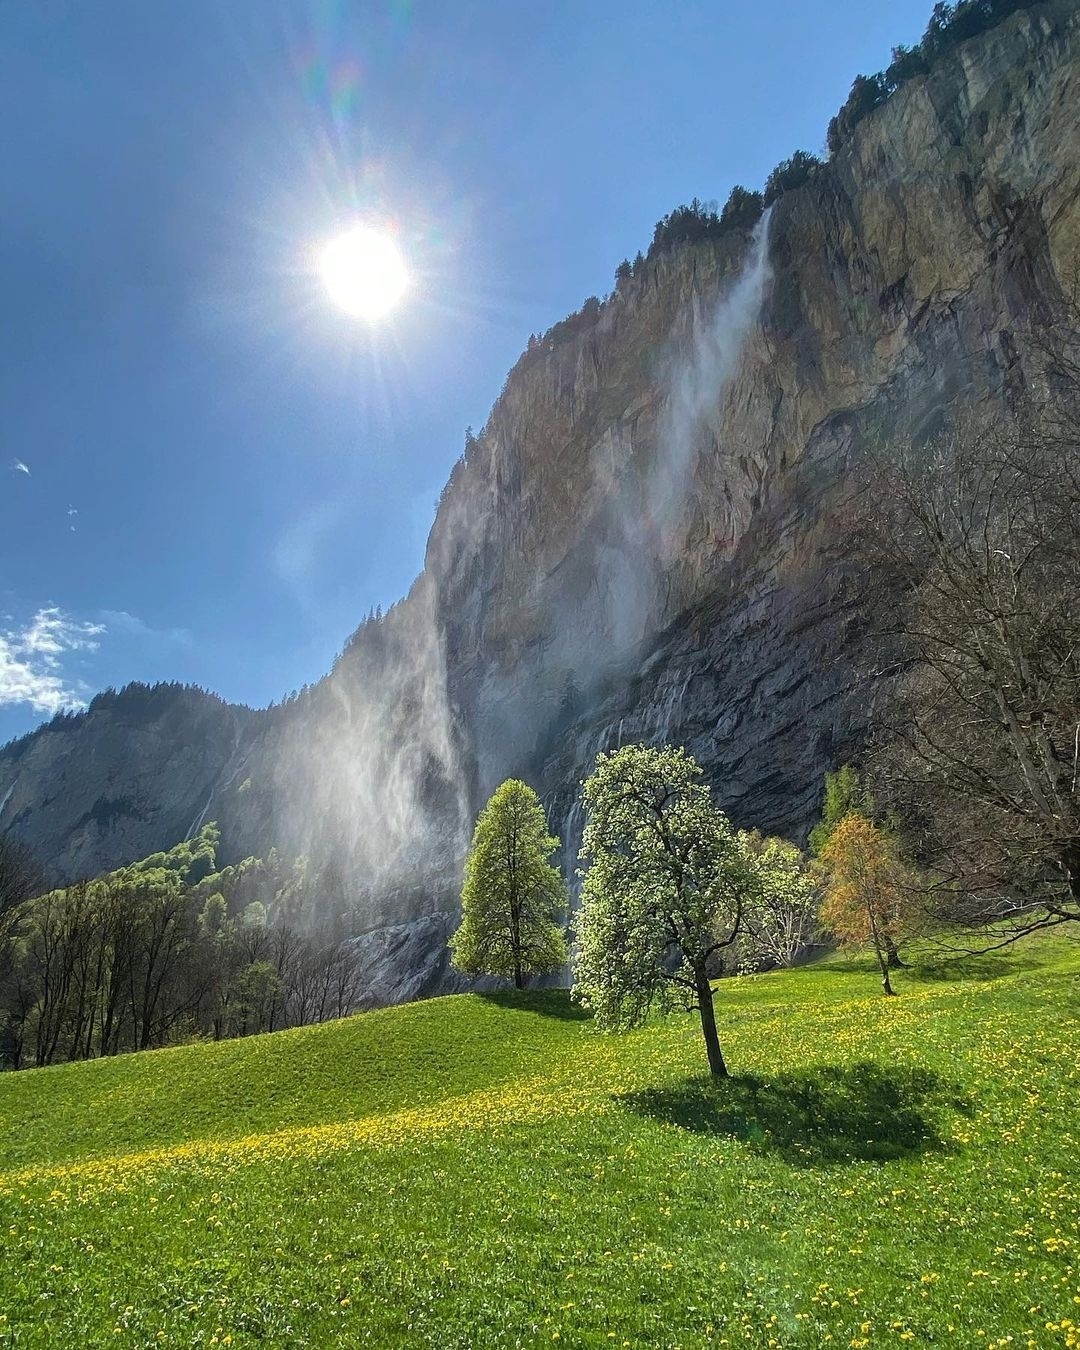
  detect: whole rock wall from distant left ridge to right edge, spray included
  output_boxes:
[0,0,1080,972]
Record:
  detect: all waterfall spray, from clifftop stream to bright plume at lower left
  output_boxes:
[240,213,771,922]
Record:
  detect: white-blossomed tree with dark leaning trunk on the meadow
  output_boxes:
[574,745,759,1076]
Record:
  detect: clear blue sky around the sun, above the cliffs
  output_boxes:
[0,0,930,741]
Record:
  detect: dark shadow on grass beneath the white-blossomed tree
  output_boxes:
[617,1062,971,1166]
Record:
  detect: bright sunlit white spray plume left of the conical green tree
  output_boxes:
[255,576,470,922]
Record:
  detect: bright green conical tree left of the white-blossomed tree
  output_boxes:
[450,778,568,990]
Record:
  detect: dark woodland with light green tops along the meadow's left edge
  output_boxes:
[0,824,362,1068]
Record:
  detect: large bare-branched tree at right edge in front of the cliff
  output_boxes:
[860,402,1080,941]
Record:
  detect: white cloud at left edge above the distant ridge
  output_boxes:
[0,605,105,713]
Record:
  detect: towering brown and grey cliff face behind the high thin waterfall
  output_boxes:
[428,4,1080,852]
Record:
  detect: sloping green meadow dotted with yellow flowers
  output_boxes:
[0,940,1080,1347]
